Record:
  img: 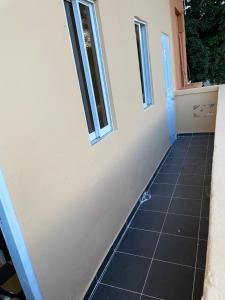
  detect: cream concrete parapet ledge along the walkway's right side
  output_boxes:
[203,85,225,300]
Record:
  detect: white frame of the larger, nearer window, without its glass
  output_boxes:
[69,0,113,144]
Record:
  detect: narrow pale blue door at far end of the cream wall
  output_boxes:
[161,33,177,144]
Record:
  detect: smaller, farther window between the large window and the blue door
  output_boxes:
[134,18,153,108]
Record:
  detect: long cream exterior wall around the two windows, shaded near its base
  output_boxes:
[0,0,174,300]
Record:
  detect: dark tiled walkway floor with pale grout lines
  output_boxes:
[89,136,214,300]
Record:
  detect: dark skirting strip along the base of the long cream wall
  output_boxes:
[83,146,172,300]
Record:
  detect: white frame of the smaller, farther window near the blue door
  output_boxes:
[134,17,153,108]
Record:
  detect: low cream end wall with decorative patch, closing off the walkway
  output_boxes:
[175,86,218,133]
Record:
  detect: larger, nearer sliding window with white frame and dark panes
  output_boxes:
[64,0,112,142]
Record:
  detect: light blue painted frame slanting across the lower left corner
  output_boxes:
[0,170,43,300]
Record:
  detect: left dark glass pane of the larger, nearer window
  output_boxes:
[64,1,95,133]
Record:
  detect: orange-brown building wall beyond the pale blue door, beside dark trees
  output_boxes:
[170,0,188,89]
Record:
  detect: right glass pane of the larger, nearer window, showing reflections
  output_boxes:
[79,3,108,128]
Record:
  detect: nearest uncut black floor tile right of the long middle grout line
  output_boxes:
[155,234,197,267]
